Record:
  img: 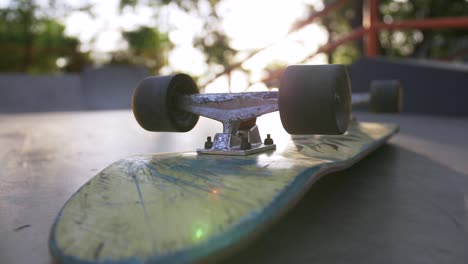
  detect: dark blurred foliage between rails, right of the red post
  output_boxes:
[379,0,468,59]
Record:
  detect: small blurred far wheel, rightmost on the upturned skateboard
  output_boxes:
[370,80,403,113]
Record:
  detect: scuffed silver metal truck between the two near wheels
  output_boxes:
[177,92,279,156]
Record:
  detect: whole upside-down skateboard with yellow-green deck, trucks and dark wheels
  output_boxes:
[49,65,401,263]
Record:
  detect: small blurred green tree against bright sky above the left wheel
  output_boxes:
[110,26,174,74]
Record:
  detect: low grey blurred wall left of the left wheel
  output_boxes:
[0,66,149,113]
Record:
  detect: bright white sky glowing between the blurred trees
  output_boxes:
[0,0,327,90]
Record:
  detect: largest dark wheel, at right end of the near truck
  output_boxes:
[278,65,351,135]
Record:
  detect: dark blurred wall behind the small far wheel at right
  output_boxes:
[349,58,468,116]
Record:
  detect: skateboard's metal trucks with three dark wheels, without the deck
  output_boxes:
[132,65,401,155]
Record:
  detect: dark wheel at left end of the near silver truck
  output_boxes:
[132,74,199,132]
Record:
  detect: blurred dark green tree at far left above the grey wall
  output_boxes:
[0,0,89,73]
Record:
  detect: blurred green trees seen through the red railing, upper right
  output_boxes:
[311,0,468,64]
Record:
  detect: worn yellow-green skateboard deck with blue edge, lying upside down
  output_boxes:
[49,122,399,263]
